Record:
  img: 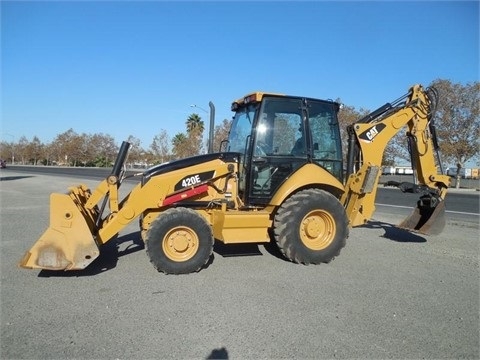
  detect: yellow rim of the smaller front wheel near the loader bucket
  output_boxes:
[162,226,198,262]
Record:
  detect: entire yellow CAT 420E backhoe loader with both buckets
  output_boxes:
[20,85,450,274]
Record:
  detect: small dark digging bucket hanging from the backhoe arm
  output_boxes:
[398,197,445,235]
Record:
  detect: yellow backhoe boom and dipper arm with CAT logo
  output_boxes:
[341,85,450,231]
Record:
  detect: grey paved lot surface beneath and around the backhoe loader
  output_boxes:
[0,171,480,359]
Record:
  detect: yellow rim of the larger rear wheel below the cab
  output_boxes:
[300,210,336,250]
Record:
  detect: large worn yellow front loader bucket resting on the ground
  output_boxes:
[19,193,100,270]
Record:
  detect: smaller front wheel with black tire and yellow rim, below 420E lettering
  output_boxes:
[145,207,214,274]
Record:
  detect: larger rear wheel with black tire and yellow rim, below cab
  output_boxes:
[273,189,348,265]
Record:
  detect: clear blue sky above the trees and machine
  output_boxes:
[0,1,480,149]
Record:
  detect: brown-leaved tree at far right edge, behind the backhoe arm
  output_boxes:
[430,79,480,188]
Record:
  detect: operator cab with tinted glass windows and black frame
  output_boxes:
[226,92,343,205]
